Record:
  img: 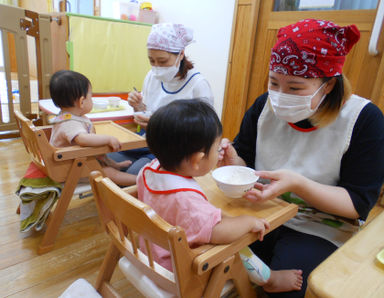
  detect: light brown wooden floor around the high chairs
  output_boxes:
[0,139,143,297]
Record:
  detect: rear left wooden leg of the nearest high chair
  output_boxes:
[95,243,120,297]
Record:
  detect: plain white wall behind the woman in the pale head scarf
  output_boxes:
[101,0,235,117]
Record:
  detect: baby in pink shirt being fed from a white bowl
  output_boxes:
[137,99,302,292]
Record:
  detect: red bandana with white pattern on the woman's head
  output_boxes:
[269,19,360,78]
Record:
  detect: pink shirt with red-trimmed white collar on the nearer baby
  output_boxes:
[137,159,221,271]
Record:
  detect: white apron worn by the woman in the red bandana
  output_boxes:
[255,95,370,246]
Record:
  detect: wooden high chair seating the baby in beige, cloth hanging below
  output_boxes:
[15,111,146,254]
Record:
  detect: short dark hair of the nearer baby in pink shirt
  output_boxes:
[146,99,222,171]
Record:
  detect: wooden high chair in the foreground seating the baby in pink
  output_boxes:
[90,171,256,297]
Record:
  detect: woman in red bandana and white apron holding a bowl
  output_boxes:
[220,19,384,297]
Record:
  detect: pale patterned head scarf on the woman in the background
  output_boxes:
[147,23,193,53]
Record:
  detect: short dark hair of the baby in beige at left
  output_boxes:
[49,70,91,108]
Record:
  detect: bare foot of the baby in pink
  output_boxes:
[263,270,303,293]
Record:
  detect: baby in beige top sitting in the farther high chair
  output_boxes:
[49,70,136,186]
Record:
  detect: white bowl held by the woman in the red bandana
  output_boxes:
[212,166,259,198]
